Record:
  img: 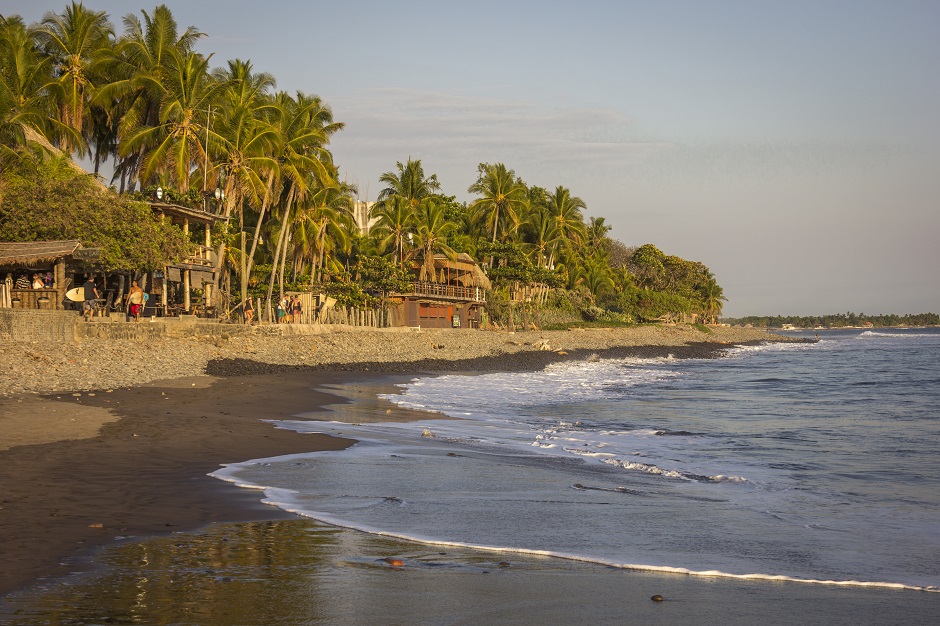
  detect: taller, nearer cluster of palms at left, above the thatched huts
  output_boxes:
[0,2,353,314]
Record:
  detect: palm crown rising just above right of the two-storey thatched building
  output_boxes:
[467,163,528,243]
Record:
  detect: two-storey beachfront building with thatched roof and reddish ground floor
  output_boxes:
[392,253,491,328]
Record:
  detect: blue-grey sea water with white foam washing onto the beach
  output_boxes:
[214,329,940,591]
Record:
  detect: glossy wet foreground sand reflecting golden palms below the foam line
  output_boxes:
[0,519,938,625]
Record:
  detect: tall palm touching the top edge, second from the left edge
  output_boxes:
[36,2,114,156]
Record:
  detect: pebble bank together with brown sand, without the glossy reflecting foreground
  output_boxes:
[0,327,792,595]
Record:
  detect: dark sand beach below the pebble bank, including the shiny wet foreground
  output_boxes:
[0,324,940,624]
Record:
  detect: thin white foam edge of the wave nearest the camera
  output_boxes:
[209,464,940,593]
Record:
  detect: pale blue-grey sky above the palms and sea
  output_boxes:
[9,0,940,317]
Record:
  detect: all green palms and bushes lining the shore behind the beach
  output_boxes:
[0,2,725,324]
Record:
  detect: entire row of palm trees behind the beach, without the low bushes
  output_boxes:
[0,2,723,324]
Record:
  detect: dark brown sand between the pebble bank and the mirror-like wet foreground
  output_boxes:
[0,372,364,595]
